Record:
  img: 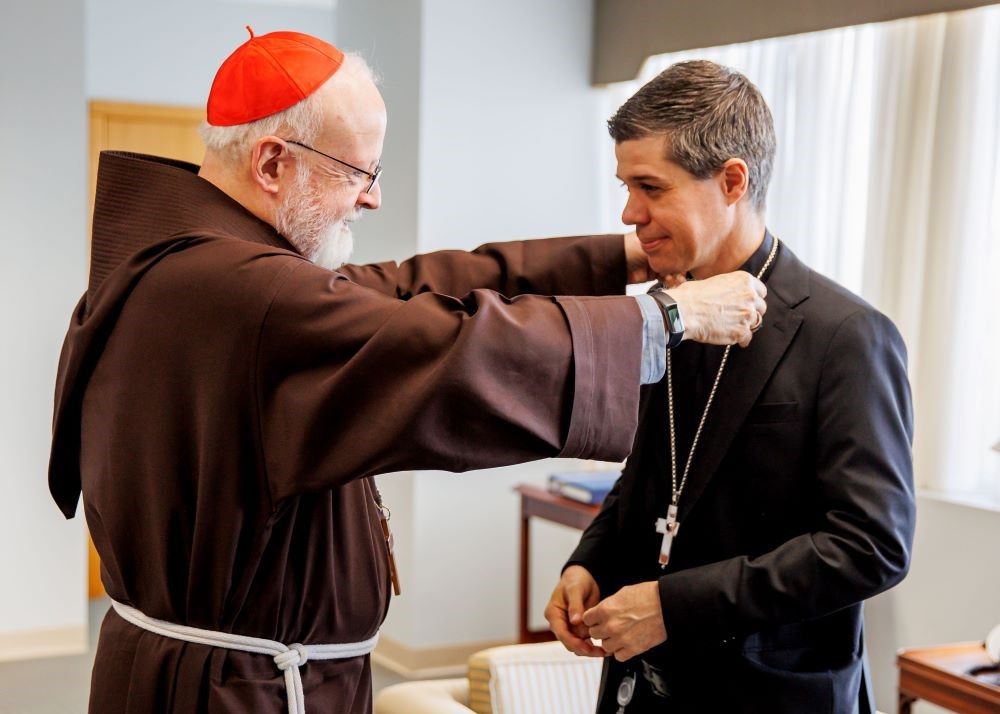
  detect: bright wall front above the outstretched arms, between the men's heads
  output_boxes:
[420,0,610,251]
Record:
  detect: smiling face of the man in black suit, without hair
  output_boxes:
[615,134,742,277]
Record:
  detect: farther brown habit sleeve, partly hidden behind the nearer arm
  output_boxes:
[338,234,626,300]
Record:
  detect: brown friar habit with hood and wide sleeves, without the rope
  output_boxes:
[49,153,642,714]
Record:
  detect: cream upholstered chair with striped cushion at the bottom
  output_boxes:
[375,642,601,714]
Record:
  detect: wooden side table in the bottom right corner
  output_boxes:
[896,642,1000,714]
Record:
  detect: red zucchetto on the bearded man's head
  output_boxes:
[208,25,344,126]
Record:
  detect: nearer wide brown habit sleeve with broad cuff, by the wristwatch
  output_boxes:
[255,254,642,503]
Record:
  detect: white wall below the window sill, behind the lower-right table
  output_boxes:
[865,495,1000,713]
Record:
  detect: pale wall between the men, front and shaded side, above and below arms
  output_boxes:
[336,0,607,649]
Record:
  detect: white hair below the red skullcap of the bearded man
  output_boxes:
[198,52,377,166]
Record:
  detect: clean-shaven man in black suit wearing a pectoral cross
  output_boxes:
[546,62,914,714]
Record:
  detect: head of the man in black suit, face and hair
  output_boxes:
[608,60,775,278]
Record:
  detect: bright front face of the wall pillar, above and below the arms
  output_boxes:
[412,0,610,646]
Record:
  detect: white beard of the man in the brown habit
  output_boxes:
[274,169,361,270]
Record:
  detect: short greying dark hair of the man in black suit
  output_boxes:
[608,60,776,212]
